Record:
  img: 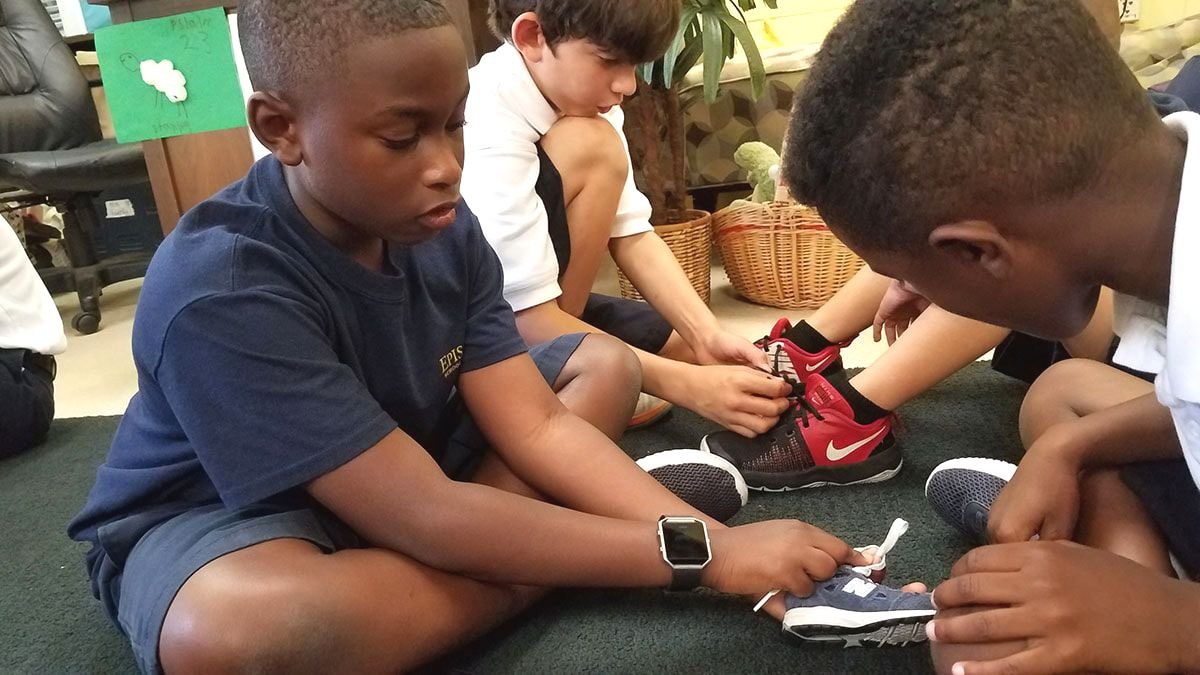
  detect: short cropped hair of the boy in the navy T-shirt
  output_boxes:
[238,0,452,92]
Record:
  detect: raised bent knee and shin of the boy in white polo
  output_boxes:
[541,118,629,317]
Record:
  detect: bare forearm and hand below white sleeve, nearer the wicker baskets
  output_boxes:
[608,232,767,368]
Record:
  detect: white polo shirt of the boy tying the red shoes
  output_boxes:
[462,42,652,311]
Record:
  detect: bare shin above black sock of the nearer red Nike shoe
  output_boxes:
[850,305,1008,411]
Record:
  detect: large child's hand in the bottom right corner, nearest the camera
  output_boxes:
[926,542,1200,675]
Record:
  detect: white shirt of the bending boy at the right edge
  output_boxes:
[1112,112,1200,485]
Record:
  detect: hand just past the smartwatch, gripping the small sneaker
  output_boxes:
[704,520,869,597]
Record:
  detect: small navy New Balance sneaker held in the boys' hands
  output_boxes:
[784,567,936,647]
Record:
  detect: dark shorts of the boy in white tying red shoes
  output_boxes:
[535,143,672,354]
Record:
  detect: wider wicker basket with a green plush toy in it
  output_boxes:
[713,196,863,310]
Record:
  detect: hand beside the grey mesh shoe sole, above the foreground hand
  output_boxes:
[988,430,1080,544]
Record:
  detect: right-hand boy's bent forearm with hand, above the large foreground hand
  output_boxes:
[988,392,1182,543]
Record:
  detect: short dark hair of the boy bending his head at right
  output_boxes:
[784,0,1158,251]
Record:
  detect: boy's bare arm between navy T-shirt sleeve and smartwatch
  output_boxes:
[308,430,671,586]
